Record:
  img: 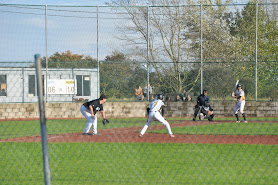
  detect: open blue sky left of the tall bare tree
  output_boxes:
[0,0,254,62]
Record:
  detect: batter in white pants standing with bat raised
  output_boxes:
[233,84,247,123]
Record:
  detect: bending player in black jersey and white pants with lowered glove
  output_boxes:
[80,94,109,135]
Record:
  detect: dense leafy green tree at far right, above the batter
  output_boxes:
[228,1,278,97]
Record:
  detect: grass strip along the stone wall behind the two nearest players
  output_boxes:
[0,118,181,139]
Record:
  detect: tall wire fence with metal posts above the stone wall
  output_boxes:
[0,3,278,102]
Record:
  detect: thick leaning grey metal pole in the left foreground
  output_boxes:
[35,54,51,185]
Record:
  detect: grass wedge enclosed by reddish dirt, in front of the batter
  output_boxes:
[150,122,278,135]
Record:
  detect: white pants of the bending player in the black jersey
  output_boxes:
[80,105,97,134]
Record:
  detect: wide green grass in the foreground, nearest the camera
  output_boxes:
[0,143,278,185]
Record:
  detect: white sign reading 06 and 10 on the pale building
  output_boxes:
[47,79,76,94]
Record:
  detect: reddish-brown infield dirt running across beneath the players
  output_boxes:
[0,121,278,145]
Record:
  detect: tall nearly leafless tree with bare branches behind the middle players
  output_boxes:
[111,0,198,92]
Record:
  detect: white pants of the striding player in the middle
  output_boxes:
[140,112,173,135]
